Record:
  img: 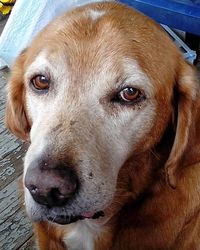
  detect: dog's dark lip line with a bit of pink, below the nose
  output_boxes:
[47,211,104,225]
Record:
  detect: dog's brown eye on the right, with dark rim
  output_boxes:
[118,87,142,102]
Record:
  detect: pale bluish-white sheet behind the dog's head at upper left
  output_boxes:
[0,0,105,69]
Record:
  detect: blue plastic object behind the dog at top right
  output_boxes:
[120,0,200,35]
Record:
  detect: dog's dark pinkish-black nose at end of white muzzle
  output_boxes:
[25,161,78,207]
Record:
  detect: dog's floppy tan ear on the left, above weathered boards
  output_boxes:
[5,50,30,140]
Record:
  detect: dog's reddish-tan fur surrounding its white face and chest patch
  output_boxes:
[6,3,200,250]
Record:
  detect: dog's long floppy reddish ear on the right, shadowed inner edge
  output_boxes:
[165,61,200,188]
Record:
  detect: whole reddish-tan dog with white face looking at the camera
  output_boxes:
[6,2,200,250]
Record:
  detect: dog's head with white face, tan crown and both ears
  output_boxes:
[6,3,197,224]
